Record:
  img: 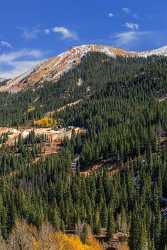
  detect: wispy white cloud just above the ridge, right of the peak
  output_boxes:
[112,31,150,47]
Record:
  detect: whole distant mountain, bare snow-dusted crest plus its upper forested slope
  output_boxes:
[0,45,167,126]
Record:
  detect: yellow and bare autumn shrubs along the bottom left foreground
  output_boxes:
[0,221,103,250]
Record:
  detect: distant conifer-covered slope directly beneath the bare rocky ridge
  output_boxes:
[0,48,166,126]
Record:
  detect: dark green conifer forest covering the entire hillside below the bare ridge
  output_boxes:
[0,53,167,250]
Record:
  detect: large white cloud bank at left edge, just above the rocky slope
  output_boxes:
[0,49,44,78]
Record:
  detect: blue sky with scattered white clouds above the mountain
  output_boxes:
[0,0,167,78]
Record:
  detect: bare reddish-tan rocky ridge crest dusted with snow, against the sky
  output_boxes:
[0,44,167,93]
